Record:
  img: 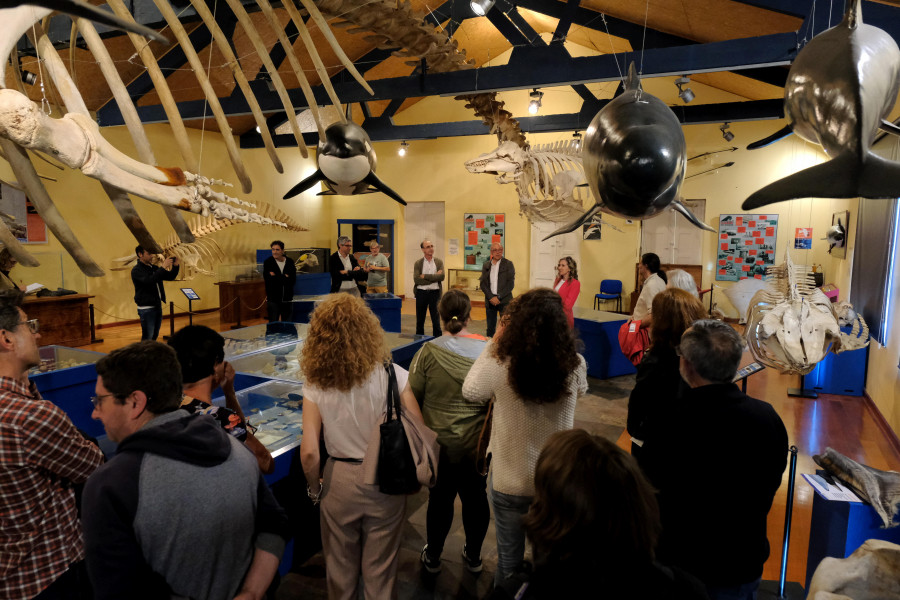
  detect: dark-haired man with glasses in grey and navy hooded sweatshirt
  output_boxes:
[82,341,288,600]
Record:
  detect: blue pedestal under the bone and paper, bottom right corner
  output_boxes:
[805,472,900,589]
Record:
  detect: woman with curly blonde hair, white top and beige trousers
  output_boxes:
[300,294,422,600]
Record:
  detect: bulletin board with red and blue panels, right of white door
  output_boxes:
[716,214,778,281]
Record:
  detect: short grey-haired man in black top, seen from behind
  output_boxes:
[639,319,788,600]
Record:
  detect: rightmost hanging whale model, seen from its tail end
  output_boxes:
[741,0,900,210]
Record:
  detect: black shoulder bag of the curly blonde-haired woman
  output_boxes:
[378,363,422,496]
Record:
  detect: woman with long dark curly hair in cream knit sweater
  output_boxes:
[463,288,587,586]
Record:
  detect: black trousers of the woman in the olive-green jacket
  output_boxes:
[425,449,491,558]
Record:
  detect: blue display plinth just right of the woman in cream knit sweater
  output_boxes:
[574,306,637,379]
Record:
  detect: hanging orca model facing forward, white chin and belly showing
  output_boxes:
[284,122,406,206]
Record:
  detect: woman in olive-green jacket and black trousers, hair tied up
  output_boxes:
[409,289,490,573]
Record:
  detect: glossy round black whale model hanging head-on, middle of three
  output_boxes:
[544,63,715,240]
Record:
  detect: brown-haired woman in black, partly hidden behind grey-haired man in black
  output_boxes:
[628,288,707,462]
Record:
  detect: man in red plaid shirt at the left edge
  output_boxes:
[0,290,103,600]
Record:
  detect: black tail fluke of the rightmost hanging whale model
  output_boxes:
[741,152,900,210]
